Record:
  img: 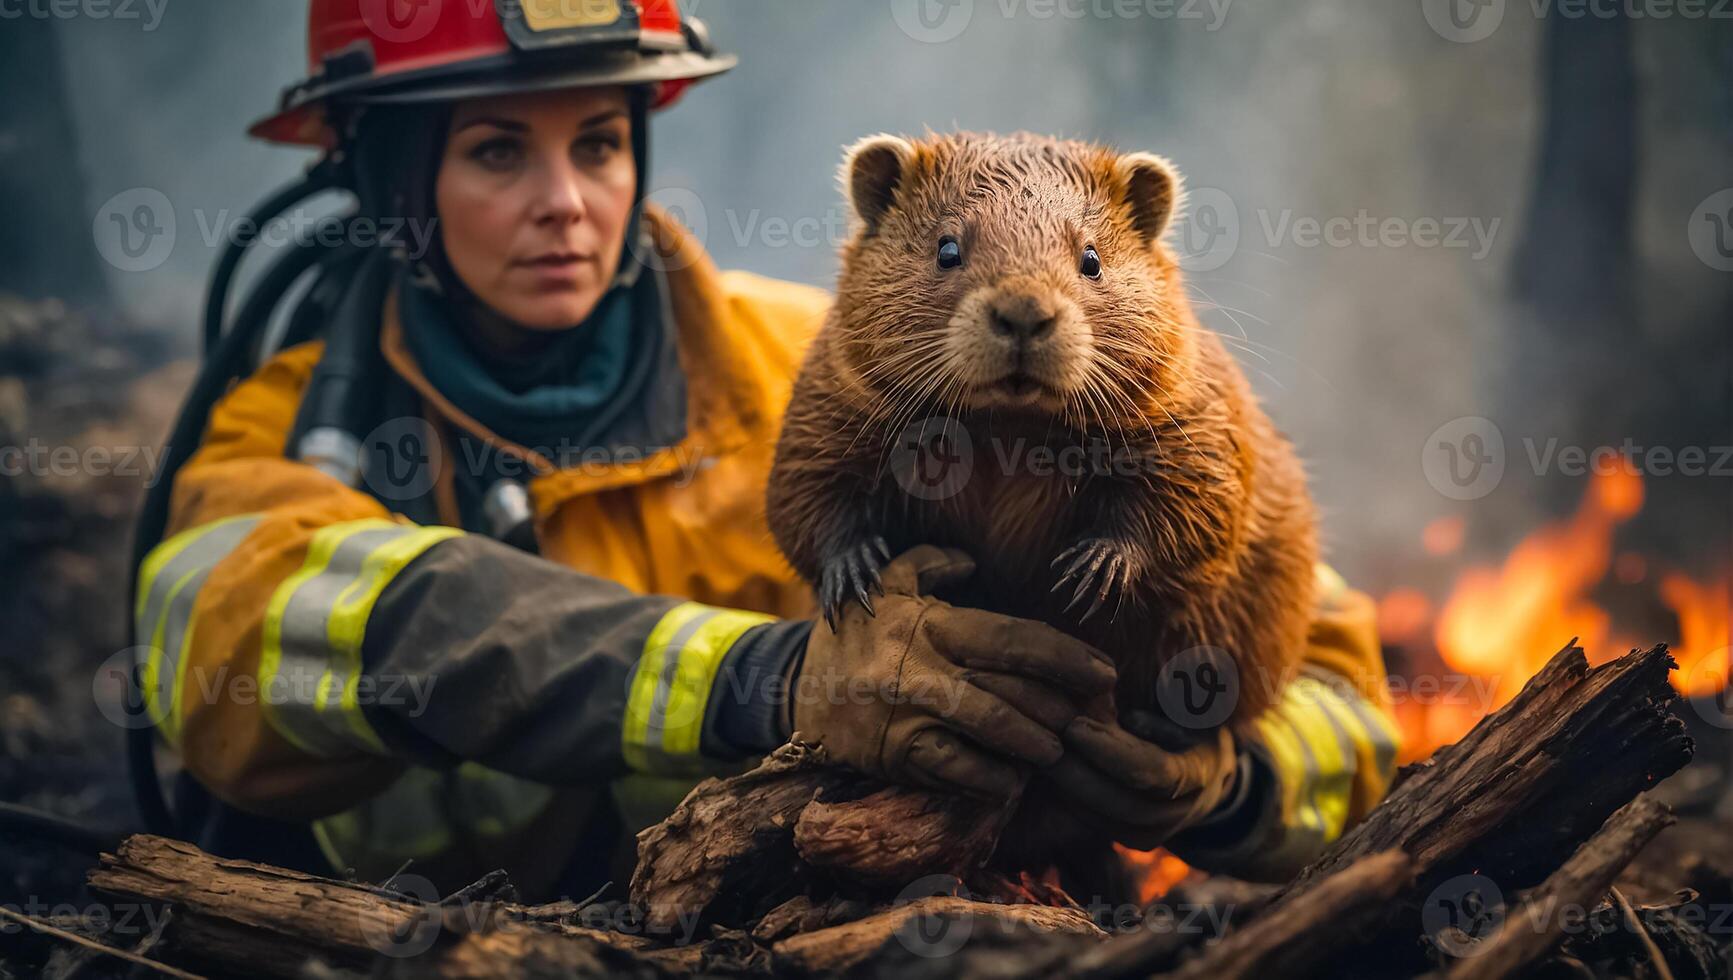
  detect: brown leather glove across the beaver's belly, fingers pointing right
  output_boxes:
[790,545,1118,798]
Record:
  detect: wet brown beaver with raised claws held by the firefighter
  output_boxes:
[768,134,1317,886]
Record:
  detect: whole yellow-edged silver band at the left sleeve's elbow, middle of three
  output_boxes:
[258,519,463,756]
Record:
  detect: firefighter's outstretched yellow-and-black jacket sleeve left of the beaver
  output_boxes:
[133,343,787,819]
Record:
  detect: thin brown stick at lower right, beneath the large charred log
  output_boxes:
[1447,798,1672,980]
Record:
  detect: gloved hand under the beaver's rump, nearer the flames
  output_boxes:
[1042,715,1239,850]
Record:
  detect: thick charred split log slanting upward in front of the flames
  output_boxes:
[1277,644,1691,904]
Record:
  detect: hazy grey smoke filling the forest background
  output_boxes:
[43,0,1733,581]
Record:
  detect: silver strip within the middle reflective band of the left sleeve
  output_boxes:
[262,522,405,756]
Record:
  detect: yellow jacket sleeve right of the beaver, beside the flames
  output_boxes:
[1170,565,1400,881]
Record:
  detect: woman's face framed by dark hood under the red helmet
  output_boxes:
[435,88,638,331]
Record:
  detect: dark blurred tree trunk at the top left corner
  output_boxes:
[0,17,107,304]
